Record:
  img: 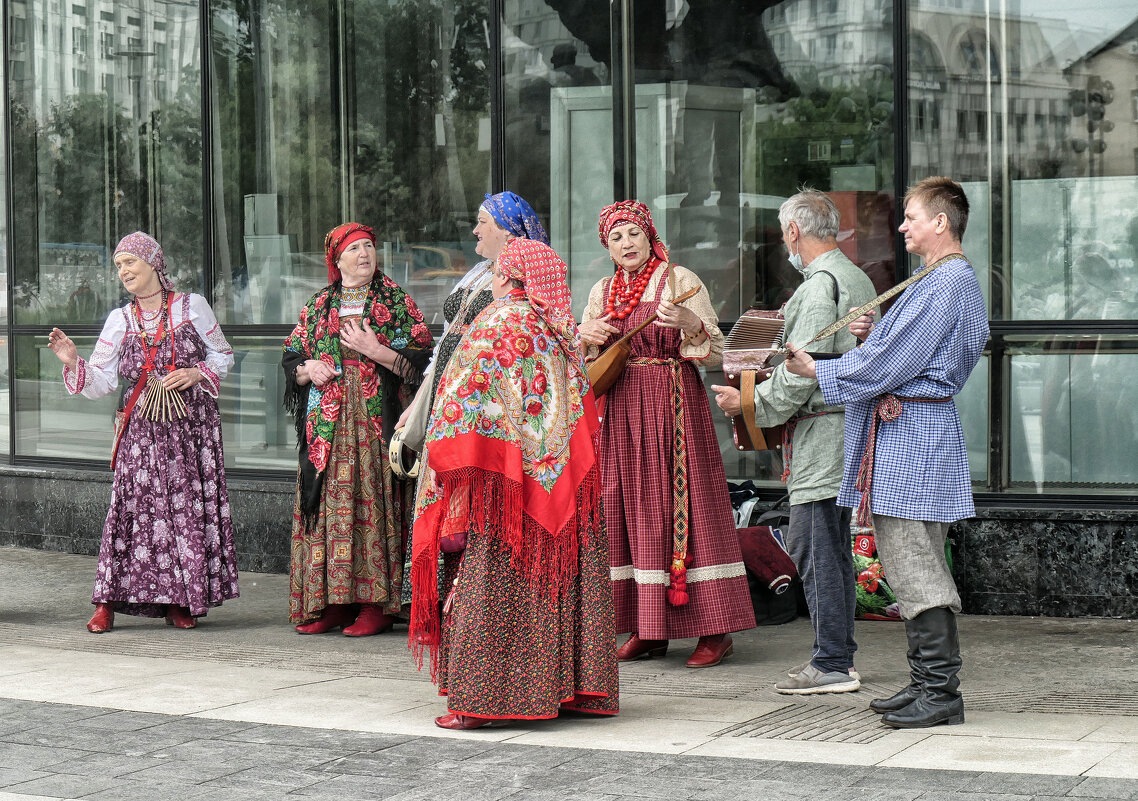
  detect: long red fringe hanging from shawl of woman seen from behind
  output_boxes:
[407,464,603,684]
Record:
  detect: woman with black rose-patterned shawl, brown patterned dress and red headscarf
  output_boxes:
[281,223,431,637]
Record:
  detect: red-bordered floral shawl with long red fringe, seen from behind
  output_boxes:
[410,290,601,674]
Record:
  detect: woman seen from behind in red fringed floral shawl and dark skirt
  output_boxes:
[410,239,618,729]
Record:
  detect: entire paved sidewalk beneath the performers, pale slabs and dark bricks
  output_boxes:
[0,547,1138,801]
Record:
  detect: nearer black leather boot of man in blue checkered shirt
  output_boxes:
[881,606,964,728]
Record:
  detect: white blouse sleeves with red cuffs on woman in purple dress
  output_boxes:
[64,292,233,398]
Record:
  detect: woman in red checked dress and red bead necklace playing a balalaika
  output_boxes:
[580,200,754,668]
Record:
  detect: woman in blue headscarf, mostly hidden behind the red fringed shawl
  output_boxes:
[396,191,550,603]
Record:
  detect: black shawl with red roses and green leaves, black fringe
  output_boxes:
[285,273,431,512]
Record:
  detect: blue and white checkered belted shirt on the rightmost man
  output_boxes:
[816,257,988,522]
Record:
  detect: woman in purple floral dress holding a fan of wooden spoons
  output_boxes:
[48,231,238,634]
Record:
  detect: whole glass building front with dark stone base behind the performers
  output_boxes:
[0,0,1138,617]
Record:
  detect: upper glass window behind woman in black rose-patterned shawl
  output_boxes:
[211,0,490,324]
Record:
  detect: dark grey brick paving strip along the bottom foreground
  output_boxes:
[0,699,1138,801]
